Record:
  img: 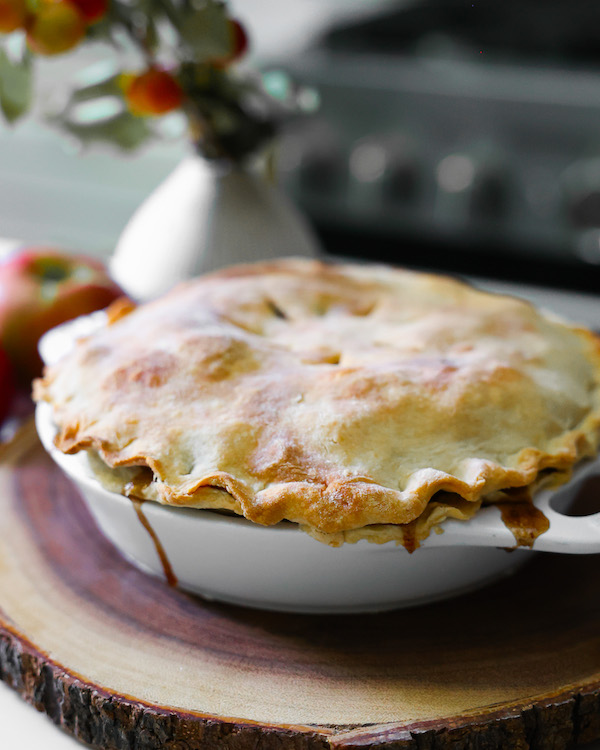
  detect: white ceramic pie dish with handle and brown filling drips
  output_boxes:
[36,313,600,613]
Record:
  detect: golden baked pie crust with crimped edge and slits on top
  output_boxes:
[34,259,600,547]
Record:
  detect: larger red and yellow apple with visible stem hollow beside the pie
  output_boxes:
[0,247,123,384]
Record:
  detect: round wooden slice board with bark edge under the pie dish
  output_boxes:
[0,430,600,750]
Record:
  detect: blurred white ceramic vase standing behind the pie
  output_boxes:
[110,155,318,301]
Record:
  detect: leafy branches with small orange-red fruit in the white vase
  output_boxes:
[0,0,299,163]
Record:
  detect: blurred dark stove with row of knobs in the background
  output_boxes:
[279,0,600,290]
